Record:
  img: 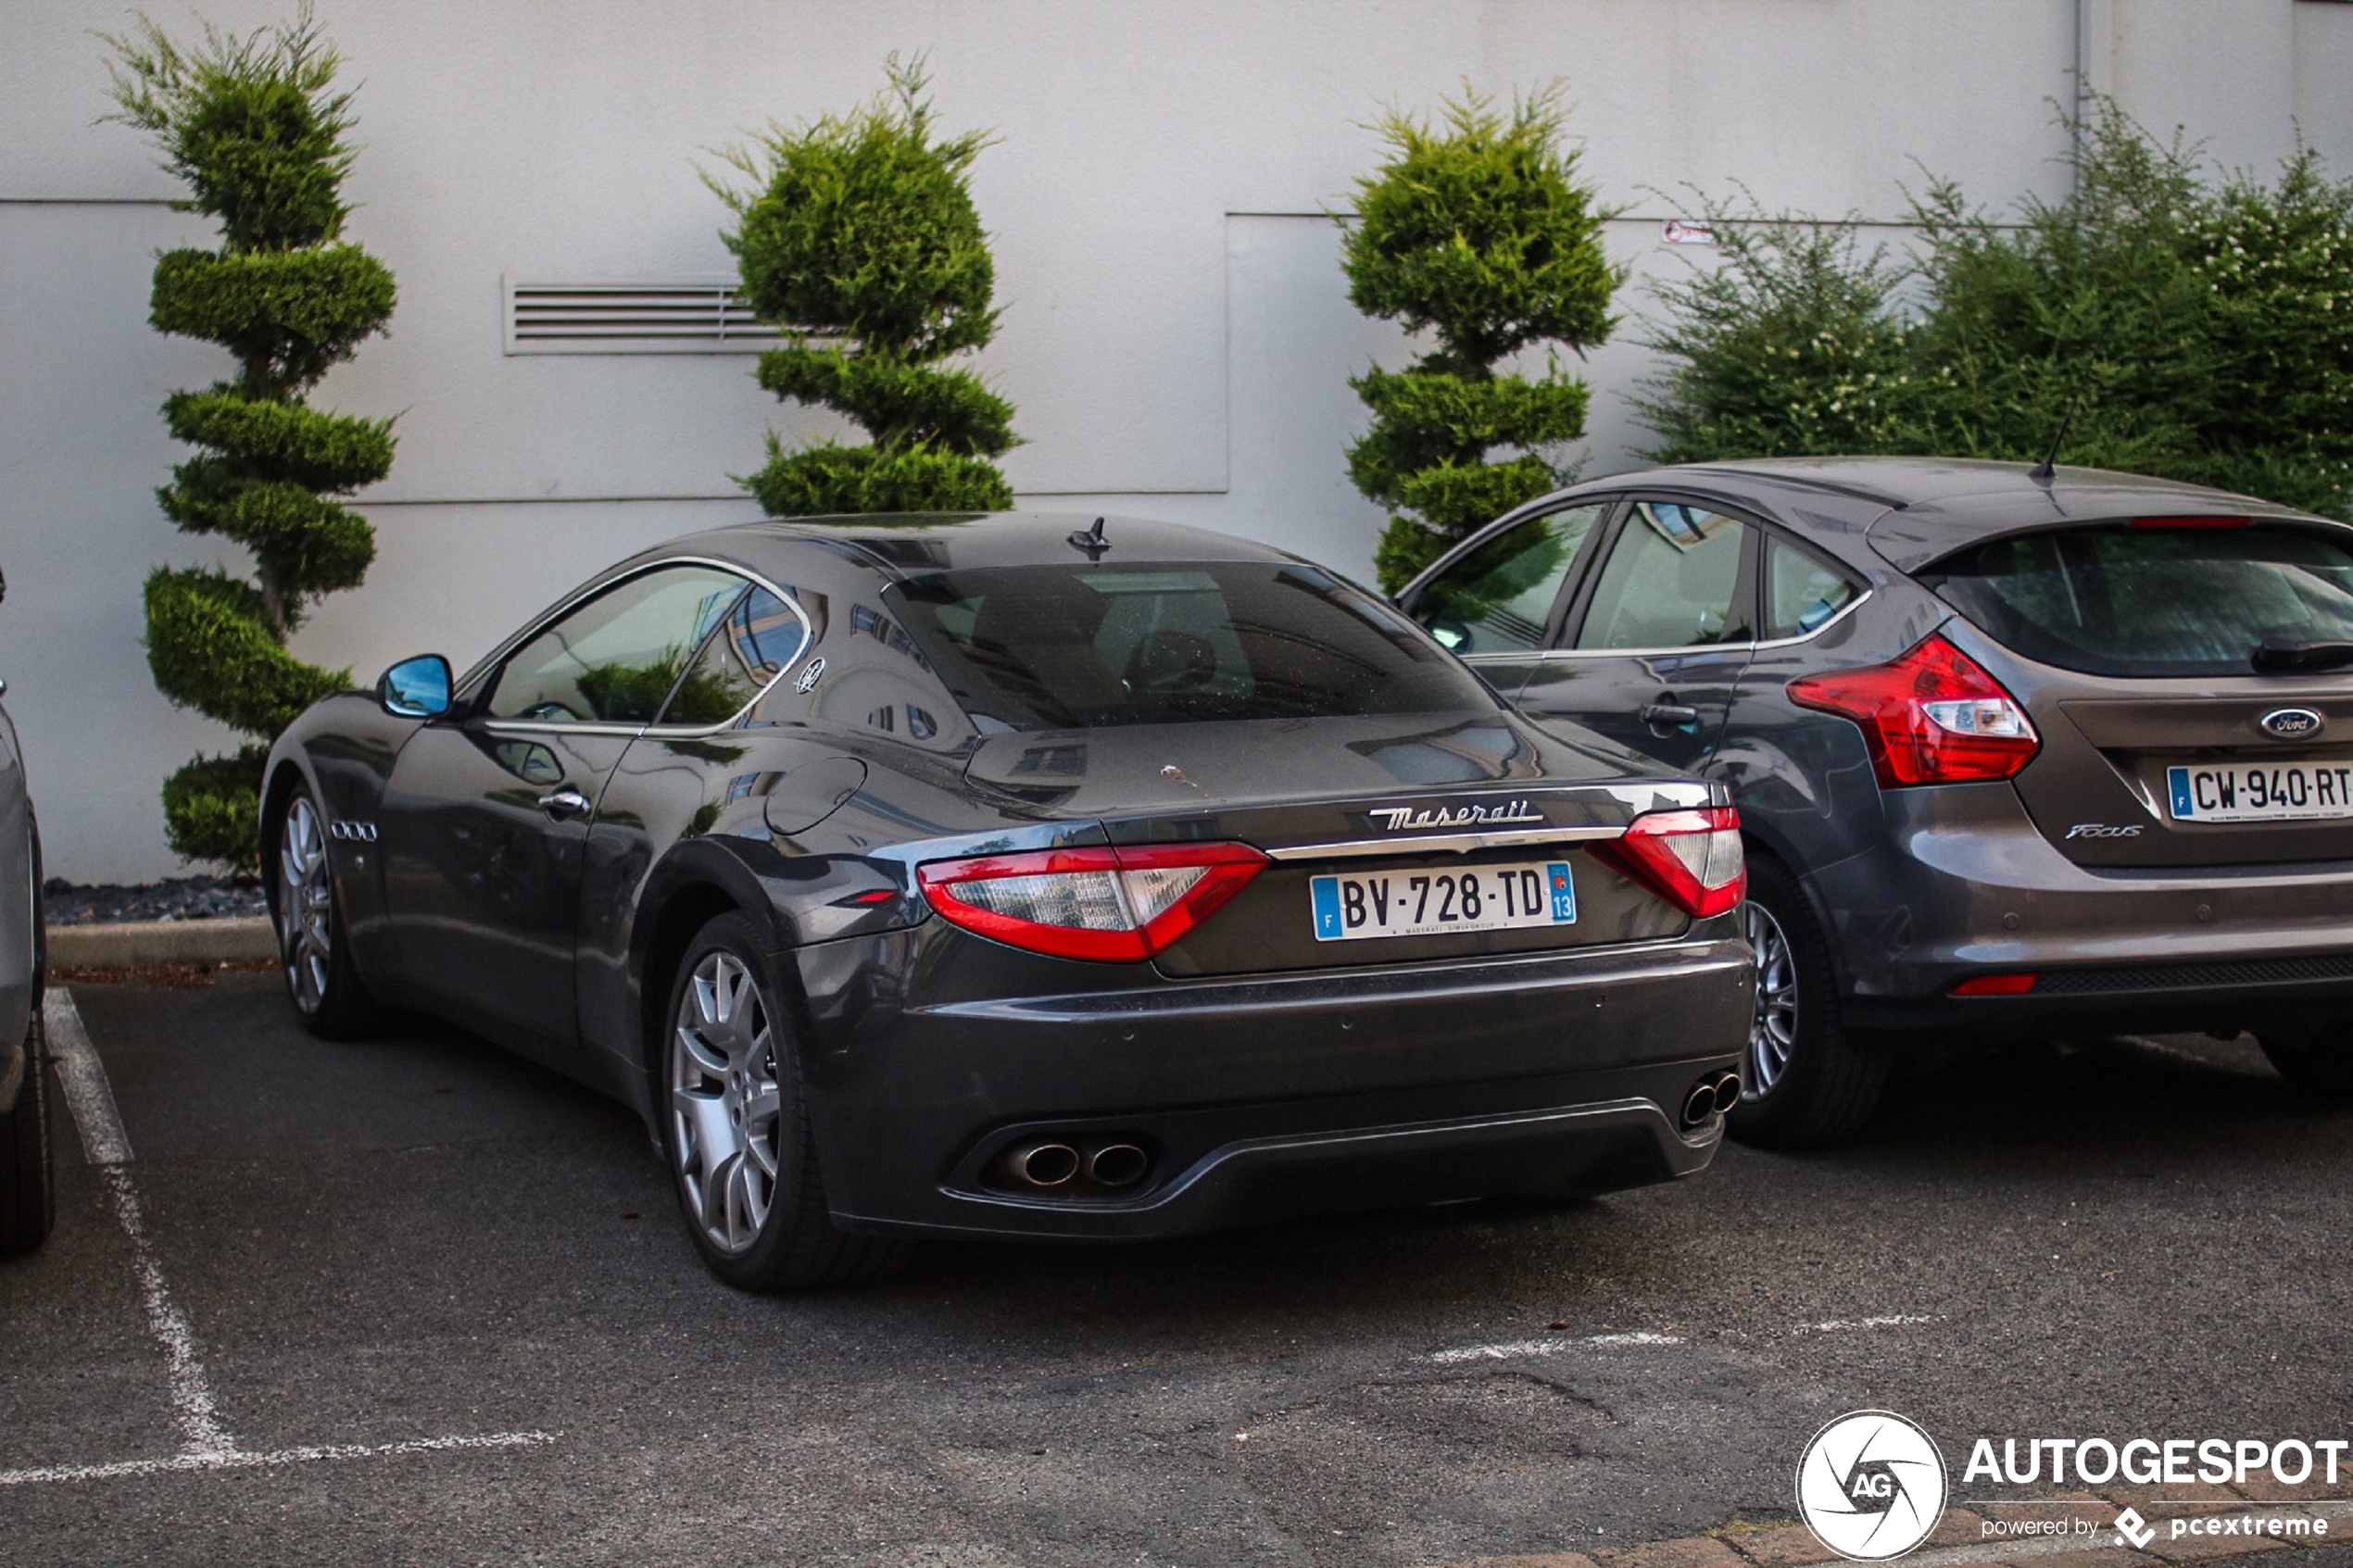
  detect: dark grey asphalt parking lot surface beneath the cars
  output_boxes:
[0,975,2353,1568]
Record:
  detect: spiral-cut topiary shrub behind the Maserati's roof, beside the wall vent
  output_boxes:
[703,54,1019,517]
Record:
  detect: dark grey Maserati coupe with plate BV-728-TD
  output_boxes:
[261,512,1751,1288]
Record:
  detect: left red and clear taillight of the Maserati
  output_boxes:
[915,844,1266,964]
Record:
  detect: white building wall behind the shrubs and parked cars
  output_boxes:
[0,0,2353,879]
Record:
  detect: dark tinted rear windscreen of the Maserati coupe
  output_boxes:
[889,562,1494,729]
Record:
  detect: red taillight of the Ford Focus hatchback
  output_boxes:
[1788,637,2043,790]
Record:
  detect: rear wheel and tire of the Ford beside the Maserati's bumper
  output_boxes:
[1725,853,1887,1149]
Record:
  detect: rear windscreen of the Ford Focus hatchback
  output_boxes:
[1918,524,2353,674]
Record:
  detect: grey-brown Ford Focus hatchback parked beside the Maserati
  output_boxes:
[1398,458,2353,1145]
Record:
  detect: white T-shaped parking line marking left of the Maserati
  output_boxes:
[0,990,555,1486]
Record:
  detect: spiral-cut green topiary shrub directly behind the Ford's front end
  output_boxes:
[1341,87,1624,590]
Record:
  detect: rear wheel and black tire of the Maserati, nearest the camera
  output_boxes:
[654,914,915,1293]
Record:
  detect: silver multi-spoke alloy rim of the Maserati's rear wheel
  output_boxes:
[671,949,784,1253]
